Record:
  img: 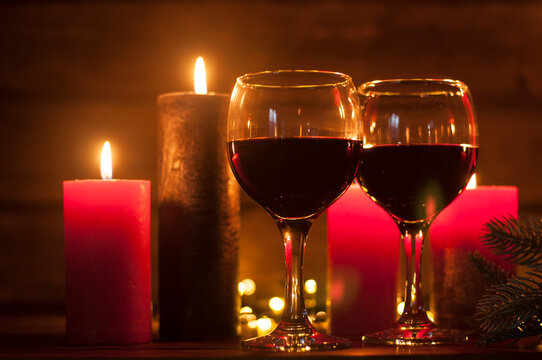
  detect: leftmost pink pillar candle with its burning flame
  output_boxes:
[64,142,152,344]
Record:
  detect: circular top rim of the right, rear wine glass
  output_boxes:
[358,78,468,96]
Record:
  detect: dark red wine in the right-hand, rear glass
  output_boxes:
[357,144,478,221]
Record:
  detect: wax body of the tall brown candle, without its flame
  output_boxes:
[158,57,240,340]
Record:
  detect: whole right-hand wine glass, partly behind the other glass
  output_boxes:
[357,79,478,345]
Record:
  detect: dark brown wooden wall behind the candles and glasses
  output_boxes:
[0,0,542,306]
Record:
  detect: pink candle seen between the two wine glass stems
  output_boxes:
[327,183,400,336]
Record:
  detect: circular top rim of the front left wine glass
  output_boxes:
[237,70,353,89]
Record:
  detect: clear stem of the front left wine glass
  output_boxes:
[277,219,312,325]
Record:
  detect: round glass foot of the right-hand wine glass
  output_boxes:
[363,323,466,346]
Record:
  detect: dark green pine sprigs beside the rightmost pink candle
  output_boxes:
[469,215,542,344]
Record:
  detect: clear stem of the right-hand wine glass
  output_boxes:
[398,221,431,326]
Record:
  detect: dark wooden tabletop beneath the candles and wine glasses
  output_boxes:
[0,314,542,360]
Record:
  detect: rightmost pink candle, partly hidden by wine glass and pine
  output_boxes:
[429,177,518,331]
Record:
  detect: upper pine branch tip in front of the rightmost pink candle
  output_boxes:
[482,215,542,268]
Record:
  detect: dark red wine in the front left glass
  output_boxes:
[228,137,362,218]
